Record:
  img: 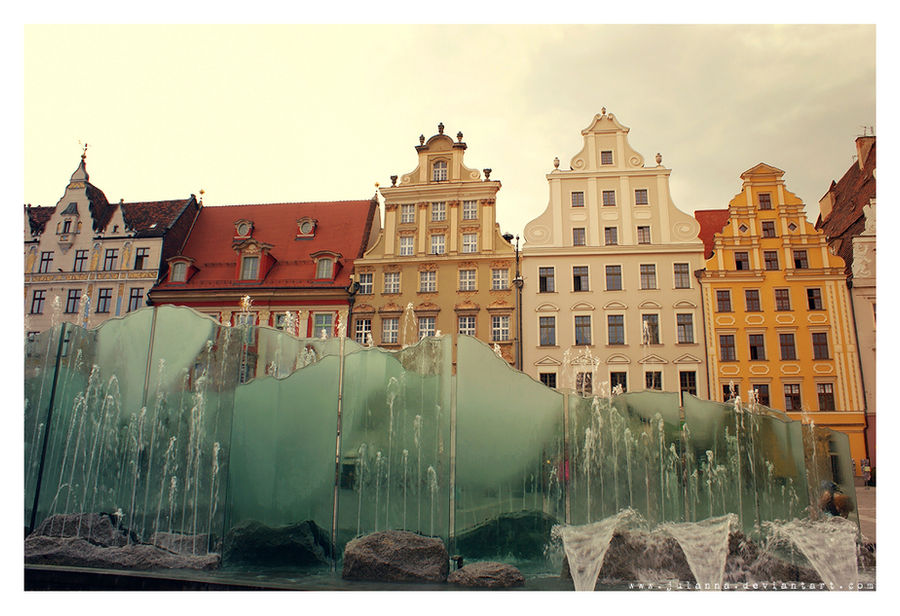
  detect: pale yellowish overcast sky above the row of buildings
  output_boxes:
[24,25,877,239]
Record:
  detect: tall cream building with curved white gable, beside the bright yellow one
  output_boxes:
[522,109,707,398]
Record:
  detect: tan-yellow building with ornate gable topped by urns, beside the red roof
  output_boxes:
[352,124,516,363]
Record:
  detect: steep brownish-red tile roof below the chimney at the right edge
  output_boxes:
[816,137,876,274]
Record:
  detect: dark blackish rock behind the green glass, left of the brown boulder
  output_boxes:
[225,520,331,566]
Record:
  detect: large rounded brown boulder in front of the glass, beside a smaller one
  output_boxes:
[342,530,450,582]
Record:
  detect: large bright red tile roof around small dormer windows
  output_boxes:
[159,199,377,290]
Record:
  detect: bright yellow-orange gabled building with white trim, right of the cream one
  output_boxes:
[697,163,866,462]
